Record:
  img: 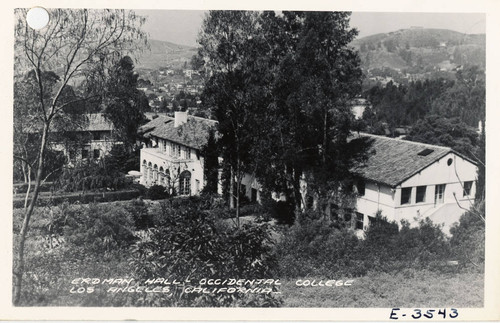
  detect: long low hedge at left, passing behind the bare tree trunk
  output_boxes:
[13,189,142,208]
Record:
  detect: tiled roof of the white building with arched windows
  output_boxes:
[139,116,217,149]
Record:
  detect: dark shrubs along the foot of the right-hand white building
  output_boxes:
[275,211,456,277]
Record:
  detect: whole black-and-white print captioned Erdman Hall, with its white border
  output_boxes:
[4,4,499,321]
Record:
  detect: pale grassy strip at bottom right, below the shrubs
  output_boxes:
[280,270,484,308]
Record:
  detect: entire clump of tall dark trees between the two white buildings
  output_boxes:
[198,11,361,218]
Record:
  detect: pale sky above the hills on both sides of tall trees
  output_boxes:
[136,10,486,46]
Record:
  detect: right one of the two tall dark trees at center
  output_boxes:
[253,12,361,210]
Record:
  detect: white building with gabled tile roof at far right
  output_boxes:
[351,134,477,232]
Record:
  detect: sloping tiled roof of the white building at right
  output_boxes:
[351,134,456,187]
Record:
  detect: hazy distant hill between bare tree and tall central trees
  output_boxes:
[132,39,196,70]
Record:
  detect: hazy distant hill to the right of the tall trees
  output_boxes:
[351,28,486,82]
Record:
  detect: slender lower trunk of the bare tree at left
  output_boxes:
[14,121,50,305]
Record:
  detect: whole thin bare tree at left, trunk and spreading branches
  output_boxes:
[14,9,147,304]
